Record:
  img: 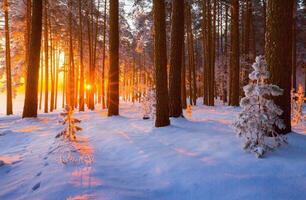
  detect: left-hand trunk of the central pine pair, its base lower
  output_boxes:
[153,0,170,127]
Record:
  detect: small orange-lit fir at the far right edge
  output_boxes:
[292,84,304,124]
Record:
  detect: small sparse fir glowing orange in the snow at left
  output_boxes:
[56,105,82,141]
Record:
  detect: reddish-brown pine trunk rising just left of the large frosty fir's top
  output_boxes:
[229,0,240,106]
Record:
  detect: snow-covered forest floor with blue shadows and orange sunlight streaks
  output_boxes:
[0,103,306,200]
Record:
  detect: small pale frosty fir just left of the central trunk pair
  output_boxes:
[141,88,156,120]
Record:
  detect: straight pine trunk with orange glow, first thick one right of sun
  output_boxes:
[108,0,119,116]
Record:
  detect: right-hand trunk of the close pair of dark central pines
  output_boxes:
[169,0,184,117]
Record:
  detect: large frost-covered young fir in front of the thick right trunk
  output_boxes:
[234,56,286,158]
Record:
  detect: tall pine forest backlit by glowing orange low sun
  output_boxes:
[0,0,306,136]
